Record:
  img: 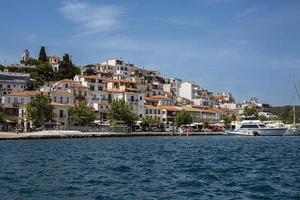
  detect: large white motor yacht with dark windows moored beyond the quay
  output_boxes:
[225,120,287,136]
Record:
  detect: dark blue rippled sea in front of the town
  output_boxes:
[0,136,300,200]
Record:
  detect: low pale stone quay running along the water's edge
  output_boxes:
[0,131,223,140]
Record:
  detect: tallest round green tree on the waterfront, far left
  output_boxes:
[26,94,54,127]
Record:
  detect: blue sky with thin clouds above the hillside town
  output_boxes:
[0,0,300,105]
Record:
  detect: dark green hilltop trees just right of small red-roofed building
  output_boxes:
[58,53,80,79]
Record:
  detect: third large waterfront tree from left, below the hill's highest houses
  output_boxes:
[108,99,138,125]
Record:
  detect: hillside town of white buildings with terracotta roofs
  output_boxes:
[0,47,273,132]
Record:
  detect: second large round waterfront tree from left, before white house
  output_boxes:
[68,101,96,126]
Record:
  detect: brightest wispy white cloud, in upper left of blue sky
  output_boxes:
[59,1,123,35]
